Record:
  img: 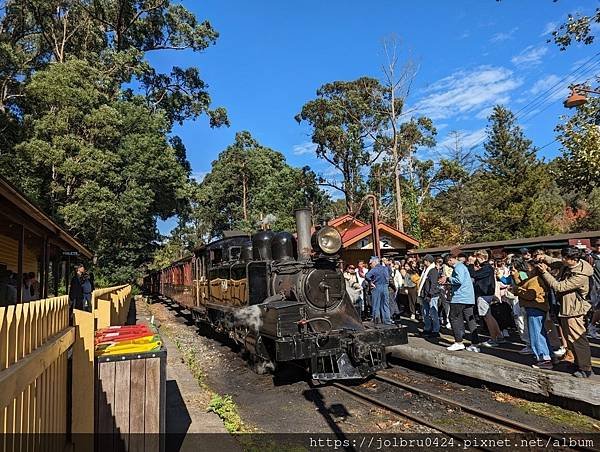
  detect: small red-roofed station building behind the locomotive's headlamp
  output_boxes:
[328,214,419,265]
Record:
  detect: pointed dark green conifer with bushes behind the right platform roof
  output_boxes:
[425,106,565,245]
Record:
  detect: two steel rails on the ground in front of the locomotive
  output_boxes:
[332,366,598,451]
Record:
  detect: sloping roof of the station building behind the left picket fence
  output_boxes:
[0,176,93,259]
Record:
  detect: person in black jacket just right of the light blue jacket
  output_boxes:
[473,250,505,347]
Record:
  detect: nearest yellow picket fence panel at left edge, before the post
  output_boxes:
[0,296,75,450]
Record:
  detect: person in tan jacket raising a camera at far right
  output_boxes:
[536,246,593,378]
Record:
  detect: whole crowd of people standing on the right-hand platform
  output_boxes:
[344,239,600,378]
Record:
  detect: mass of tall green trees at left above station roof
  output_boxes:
[0,0,228,284]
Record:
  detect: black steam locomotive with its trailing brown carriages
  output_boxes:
[144,209,407,381]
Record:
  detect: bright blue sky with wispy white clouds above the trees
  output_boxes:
[156,0,600,233]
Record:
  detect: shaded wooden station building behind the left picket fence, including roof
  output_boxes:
[0,176,92,305]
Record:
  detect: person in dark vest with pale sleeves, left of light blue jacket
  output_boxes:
[417,254,442,338]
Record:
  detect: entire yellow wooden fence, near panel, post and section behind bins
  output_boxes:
[0,286,131,451]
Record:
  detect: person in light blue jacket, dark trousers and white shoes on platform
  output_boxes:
[441,248,479,352]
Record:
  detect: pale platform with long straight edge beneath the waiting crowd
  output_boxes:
[388,319,600,416]
